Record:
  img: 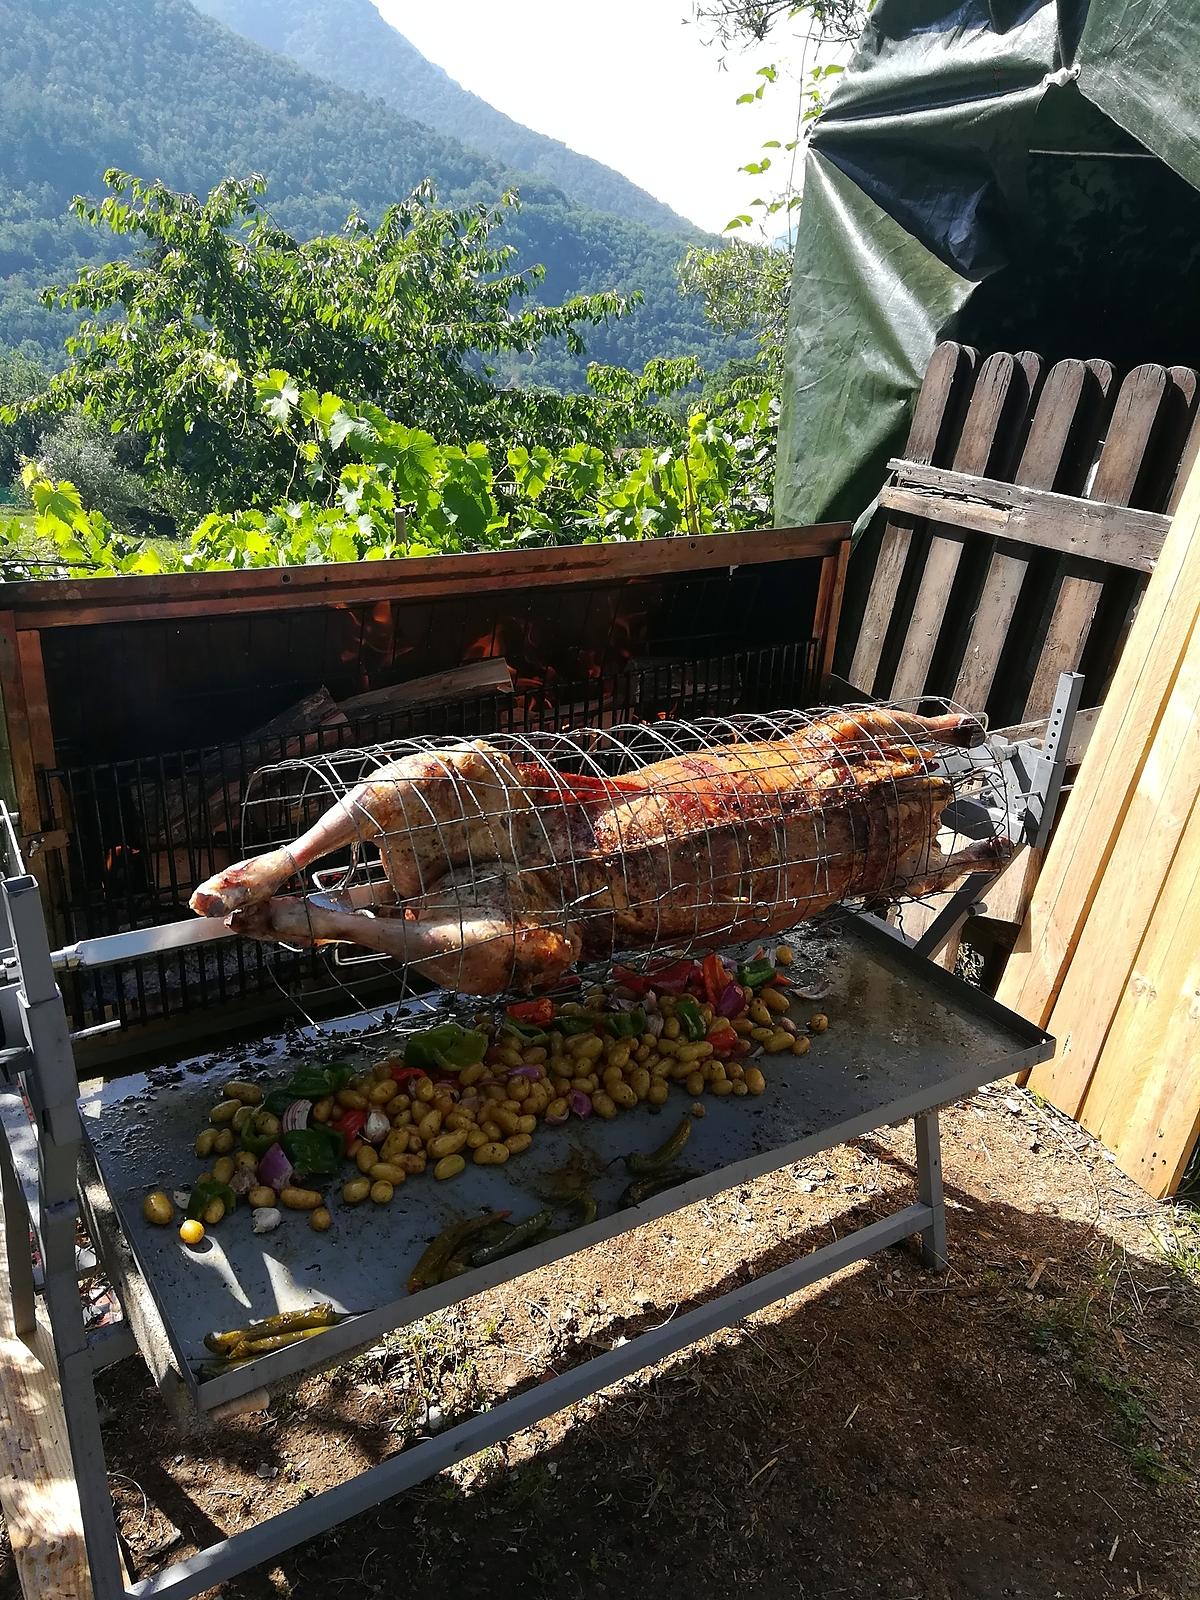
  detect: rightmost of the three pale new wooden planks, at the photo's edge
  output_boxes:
[1082,803,1200,1198]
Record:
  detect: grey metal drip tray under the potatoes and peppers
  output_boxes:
[80,917,1051,1408]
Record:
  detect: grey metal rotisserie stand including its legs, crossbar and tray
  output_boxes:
[0,682,1078,1600]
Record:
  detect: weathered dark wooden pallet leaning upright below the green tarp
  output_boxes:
[837,344,1200,928]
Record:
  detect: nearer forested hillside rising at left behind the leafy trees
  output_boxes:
[0,0,730,382]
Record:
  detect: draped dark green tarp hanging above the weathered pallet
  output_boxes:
[776,0,1200,525]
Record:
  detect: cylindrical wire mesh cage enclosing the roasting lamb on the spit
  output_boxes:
[192,702,1010,995]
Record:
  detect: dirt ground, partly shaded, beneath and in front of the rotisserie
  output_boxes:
[0,1088,1200,1600]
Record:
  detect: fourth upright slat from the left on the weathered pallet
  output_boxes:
[1024,363,1168,717]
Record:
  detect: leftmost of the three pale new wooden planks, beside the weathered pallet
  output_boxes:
[998,444,1200,1027]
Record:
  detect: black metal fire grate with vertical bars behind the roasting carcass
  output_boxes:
[42,640,818,1029]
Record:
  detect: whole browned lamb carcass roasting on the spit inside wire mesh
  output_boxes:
[192,707,1002,995]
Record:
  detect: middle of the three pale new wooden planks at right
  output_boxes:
[1029,629,1200,1117]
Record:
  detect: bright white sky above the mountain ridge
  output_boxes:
[376,0,825,234]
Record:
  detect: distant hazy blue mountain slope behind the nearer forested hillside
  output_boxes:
[194,0,693,232]
